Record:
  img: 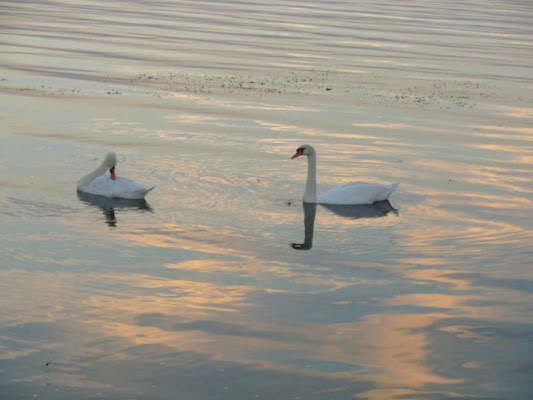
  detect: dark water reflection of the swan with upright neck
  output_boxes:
[291,200,398,250]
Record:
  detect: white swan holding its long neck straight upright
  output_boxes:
[291,144,399,205]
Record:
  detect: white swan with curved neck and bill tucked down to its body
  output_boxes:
[78,152,155,199]
